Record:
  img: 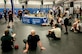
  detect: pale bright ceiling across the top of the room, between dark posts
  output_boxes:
[0,0,82,8]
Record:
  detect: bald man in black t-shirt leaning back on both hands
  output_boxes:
[23,30,45,53]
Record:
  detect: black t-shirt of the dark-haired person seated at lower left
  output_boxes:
[1,36,12,51]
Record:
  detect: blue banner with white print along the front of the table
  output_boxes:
[22,16,48,25]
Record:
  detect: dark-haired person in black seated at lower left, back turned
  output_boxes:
[1,30,13,52]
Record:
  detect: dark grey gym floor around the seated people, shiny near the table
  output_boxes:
[0,20,82,54]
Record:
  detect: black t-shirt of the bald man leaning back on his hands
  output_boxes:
[27,35,40,50]
